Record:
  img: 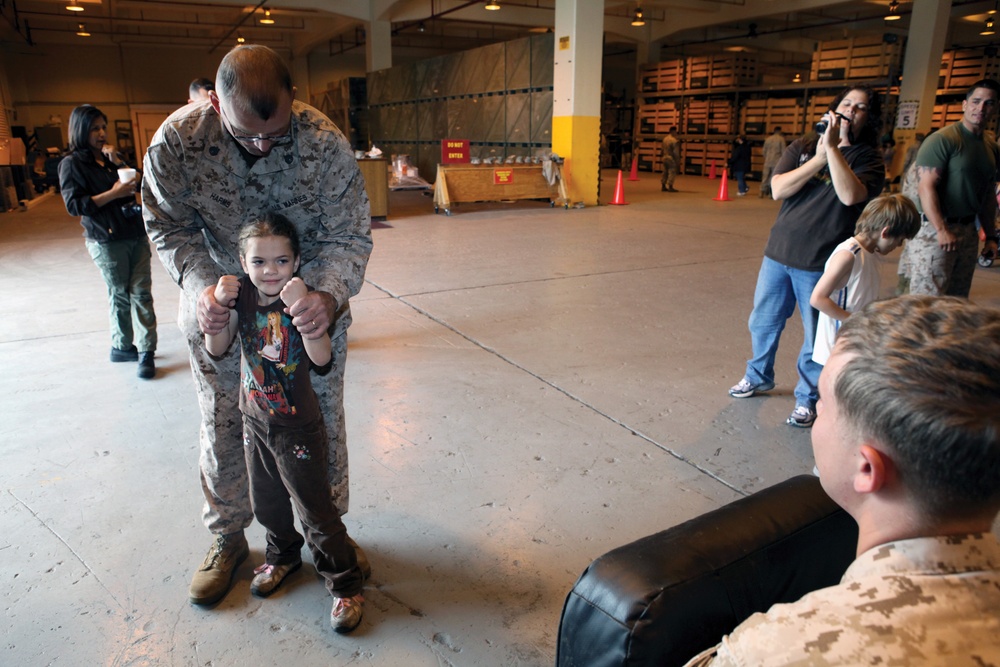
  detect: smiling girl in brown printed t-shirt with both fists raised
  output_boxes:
[205,213,364,632]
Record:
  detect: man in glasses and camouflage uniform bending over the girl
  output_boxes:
[143,45,372,605]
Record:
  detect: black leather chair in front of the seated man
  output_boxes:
[556,475,858,667]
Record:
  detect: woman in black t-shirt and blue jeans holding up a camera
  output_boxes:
[729,85,885,428]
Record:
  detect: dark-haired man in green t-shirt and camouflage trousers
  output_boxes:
[907,79,1000,298]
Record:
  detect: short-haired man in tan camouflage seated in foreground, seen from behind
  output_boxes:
[700,295,1000,667]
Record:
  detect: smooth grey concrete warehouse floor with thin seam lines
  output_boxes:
[0,171,1000,667]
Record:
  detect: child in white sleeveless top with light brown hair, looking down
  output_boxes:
[809,194,920,365]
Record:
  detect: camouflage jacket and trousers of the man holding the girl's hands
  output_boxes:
[143,102,372,535]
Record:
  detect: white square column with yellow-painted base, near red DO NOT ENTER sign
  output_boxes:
[552,0,604,206]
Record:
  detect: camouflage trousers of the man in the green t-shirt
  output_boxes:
[906,219,979,298]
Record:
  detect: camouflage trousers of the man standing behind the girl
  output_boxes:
[178,294,350,534]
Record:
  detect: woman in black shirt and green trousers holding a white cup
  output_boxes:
[59,104,156,380]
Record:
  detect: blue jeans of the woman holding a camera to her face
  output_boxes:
[746,257,823,409]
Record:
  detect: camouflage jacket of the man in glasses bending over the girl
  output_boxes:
[142,102,372,338]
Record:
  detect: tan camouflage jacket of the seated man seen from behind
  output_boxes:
[688,533,1000,667]
